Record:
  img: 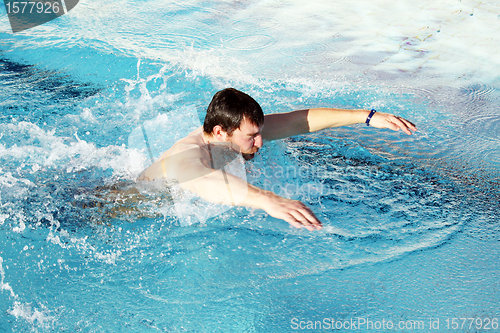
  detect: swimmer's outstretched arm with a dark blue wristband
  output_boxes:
[262,108,417,140]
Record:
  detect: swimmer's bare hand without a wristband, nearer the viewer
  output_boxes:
[263,193,323,231]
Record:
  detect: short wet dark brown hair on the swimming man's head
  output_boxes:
[203,88,264,135]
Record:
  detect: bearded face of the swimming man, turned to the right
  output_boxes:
[227,118,264,160]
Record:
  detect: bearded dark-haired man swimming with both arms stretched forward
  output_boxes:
[138,88,417,230]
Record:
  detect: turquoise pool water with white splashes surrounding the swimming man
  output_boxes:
[0,1,500,332]
